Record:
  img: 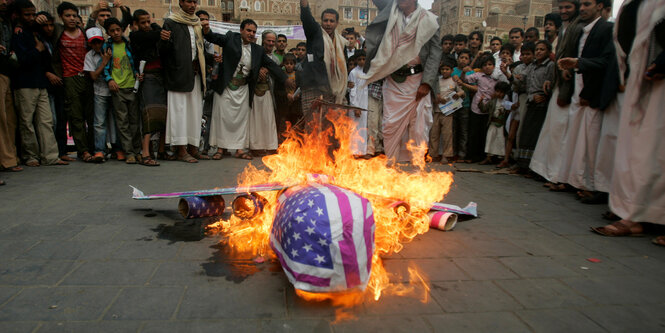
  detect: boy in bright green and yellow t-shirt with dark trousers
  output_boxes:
[103,17,142,164]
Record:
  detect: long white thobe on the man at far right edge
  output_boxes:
[610,1,665,224]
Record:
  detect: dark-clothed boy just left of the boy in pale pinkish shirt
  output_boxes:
[453,49,474,163]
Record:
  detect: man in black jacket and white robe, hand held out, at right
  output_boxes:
[557,0,616,197]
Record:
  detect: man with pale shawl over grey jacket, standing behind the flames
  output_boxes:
[362,0,442,162]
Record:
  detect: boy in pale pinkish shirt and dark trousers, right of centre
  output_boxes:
[457,55,497,162]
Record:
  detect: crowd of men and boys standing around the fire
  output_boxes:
[0,0,665,245]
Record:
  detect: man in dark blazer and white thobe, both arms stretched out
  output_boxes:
[204,19,287,159]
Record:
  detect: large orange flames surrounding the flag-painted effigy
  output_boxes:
[208,105,453,306]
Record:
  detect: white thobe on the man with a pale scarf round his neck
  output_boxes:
[165,26,203,147]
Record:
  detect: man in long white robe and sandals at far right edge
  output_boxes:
[592,0,665,240]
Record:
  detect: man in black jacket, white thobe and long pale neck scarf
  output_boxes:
[158,0,206,163]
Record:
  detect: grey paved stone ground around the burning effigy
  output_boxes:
[0,158,665,332]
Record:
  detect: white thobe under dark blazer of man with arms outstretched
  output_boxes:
[210,44,252,149]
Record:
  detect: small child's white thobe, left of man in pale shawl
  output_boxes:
[348,67,369,155]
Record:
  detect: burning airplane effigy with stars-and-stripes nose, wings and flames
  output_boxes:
[134,104,476,304]
